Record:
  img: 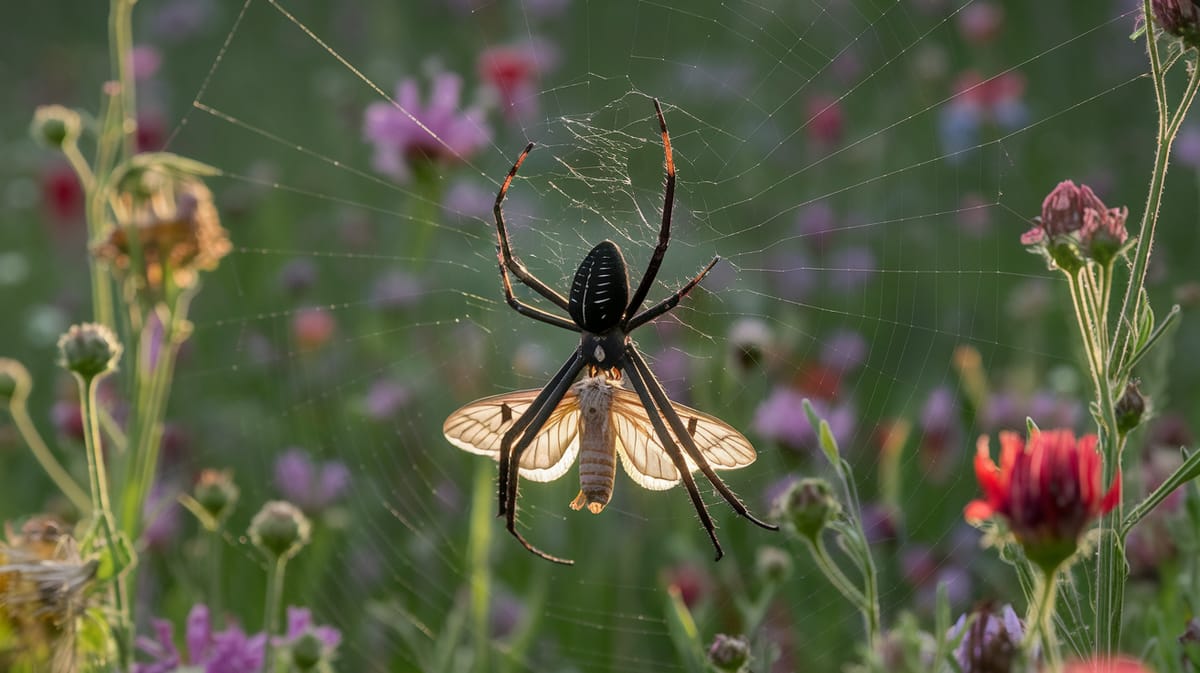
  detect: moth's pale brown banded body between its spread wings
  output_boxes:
[571,377,617,515]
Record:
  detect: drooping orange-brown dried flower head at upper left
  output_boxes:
[94,163,233,298]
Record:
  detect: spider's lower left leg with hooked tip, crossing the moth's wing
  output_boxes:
[500,351,583,565]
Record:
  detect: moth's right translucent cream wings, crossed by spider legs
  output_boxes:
[612,389,756,491]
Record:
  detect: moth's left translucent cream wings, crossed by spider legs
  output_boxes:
[442,389,580,481]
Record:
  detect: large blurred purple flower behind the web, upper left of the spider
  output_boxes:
[362,73,491,181]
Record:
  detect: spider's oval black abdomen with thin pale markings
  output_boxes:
[568,241,629,334]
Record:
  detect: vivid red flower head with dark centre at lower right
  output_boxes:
[964,429,1121,570]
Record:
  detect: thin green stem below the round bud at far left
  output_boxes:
[76,375,133,671]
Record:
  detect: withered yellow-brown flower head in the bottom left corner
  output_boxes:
[0,516,98,669]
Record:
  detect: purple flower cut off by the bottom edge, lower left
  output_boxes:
[133,605,266,673]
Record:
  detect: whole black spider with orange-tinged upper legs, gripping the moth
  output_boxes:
[493,100,779,564]
